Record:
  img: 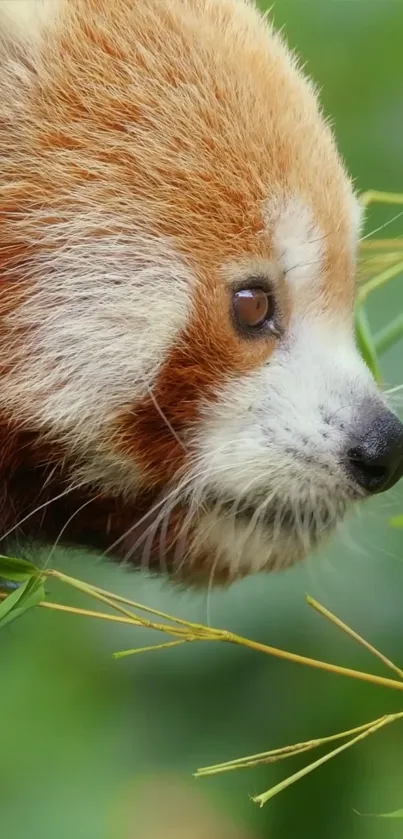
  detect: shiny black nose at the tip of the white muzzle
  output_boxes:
[347,408,403,495]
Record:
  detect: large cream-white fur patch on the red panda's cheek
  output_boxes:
[0,226,193,487]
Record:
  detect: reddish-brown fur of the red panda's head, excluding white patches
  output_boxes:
[0,0,360,580]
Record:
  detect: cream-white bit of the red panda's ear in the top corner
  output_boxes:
[0,0,61,49]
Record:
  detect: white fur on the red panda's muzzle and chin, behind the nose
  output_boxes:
[188,318,380,575]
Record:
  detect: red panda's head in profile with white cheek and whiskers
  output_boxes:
[0,0,403,584]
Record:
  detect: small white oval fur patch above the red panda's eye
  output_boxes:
[273,197,324,289]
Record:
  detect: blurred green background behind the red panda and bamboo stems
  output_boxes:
[0,0,403,839]
